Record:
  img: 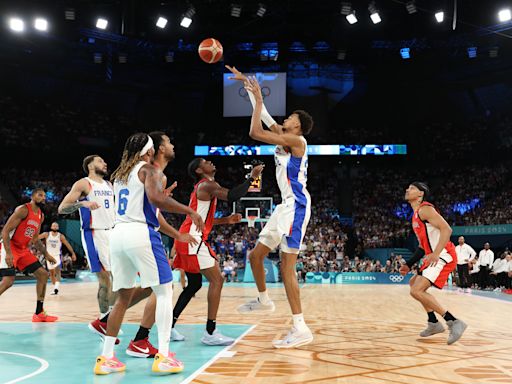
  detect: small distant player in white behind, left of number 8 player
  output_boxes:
[39,222,76,295]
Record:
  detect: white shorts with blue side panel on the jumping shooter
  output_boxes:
[258,201,311,254]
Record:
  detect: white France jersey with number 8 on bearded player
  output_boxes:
[80,177,115,229]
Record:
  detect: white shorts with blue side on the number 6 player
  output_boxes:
[110,223,172,291]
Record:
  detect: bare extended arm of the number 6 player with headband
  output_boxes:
[140,164,204,231]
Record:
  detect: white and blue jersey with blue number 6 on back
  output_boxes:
[114,161,158,228]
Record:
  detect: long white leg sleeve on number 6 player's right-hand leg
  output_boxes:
[152,283,172,357]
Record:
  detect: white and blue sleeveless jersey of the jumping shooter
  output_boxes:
[274,136,311,206]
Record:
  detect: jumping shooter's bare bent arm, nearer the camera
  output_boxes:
[245,78,304,152]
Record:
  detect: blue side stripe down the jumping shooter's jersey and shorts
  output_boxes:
[286,155,308,249]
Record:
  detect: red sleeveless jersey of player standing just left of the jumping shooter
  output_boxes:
[176,179,217,254]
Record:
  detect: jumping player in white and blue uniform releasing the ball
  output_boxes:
[229,68,313,348]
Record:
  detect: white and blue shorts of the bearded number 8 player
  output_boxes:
[82,229,112,272]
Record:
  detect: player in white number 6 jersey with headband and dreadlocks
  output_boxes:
[94,133,204,375]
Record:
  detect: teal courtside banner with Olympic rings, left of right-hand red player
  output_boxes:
[306,272,413,284]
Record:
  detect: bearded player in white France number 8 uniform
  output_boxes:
[58,155,115,317]
